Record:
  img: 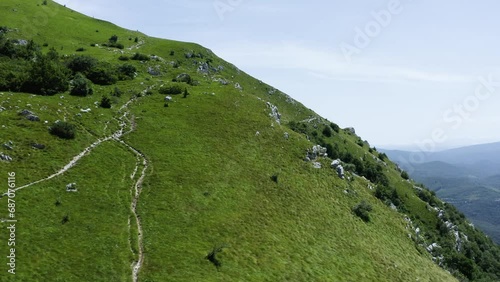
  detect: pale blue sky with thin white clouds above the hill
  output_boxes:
[56,0,500,149]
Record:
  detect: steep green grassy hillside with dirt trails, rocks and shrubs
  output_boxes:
[0,0,500,281]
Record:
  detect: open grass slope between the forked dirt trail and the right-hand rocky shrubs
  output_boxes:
[127,81,452,281]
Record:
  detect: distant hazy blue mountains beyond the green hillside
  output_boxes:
[380,142,500,243]
